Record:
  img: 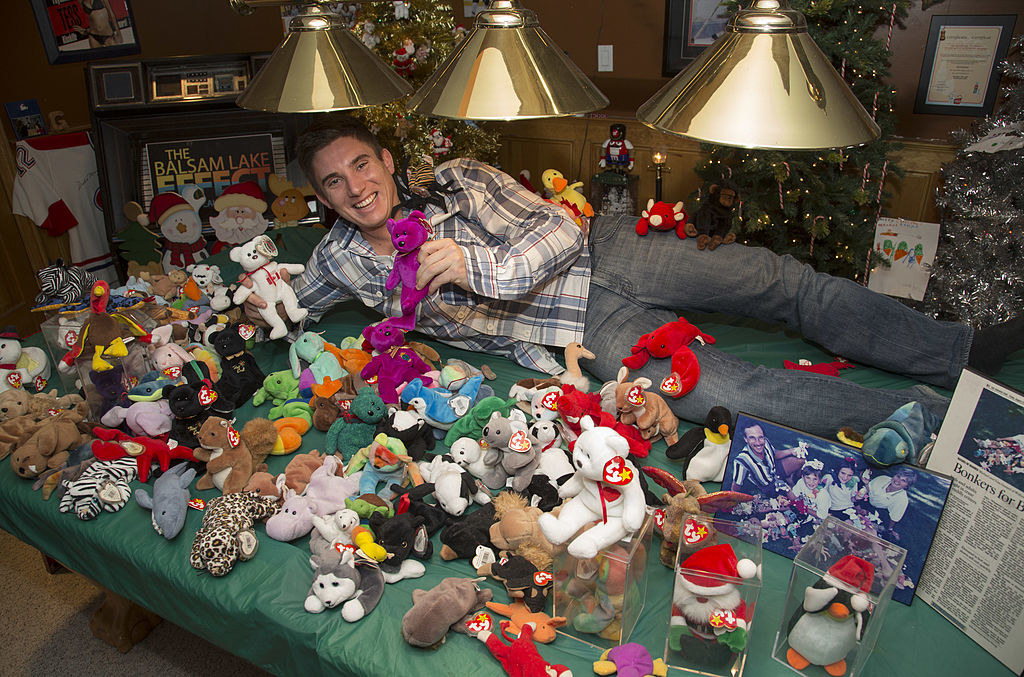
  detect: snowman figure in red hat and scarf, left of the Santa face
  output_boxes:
[136,186,208,273]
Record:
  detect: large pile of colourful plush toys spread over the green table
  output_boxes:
[8,216,925,675]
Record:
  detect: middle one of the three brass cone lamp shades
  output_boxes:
[408,0,608,120]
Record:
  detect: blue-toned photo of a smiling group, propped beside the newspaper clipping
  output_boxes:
[717,414,950,604]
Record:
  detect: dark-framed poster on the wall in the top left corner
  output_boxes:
[30,0,140,64]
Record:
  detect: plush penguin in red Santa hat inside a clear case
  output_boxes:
[785,555,874,677]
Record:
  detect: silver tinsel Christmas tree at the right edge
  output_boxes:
[915,37,1024,328]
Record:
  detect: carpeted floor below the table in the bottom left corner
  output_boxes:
[0,530,266,677]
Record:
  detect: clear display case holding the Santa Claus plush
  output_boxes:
[665,515,761,677]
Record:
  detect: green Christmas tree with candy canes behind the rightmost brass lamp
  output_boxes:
[696,0,910,281]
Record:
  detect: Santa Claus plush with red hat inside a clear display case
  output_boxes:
[670,536,760,667]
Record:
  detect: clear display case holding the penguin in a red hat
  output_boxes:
[772,517,906,677]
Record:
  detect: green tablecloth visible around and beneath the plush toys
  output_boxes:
[0,306,1024,677]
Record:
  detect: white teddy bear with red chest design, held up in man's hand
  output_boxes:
[229,236,309,340]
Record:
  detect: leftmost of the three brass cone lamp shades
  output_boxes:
[237,6,413,113]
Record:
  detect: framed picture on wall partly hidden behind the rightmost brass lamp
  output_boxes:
[663,0,729,76]
